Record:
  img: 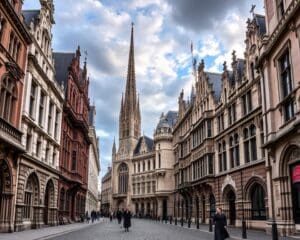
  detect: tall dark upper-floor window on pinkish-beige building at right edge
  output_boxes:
[279,50,295,121]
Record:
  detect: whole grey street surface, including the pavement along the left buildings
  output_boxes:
[0,219,300,240]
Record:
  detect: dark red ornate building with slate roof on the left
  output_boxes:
[54,47,91,221]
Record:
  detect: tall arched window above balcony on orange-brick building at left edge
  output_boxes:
[0,77,17,122]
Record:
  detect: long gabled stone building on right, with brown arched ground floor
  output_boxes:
[173,14,268,231]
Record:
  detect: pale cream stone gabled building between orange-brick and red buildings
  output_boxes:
[15,0,64,231]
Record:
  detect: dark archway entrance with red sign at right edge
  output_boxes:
[290,161,300,224]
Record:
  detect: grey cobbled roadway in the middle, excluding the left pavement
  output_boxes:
[49,219,298,240]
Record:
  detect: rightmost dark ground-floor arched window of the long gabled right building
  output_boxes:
[251,183,266,220]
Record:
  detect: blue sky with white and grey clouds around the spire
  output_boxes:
[24,0,264,187]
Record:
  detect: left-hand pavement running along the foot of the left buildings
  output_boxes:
[0,219,103,240]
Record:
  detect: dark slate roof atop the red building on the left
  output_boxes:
[53,53,75,89]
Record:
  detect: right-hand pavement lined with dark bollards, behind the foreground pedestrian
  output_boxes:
[150,221,300,240]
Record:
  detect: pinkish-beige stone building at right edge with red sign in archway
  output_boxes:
[256,0,300,236]
